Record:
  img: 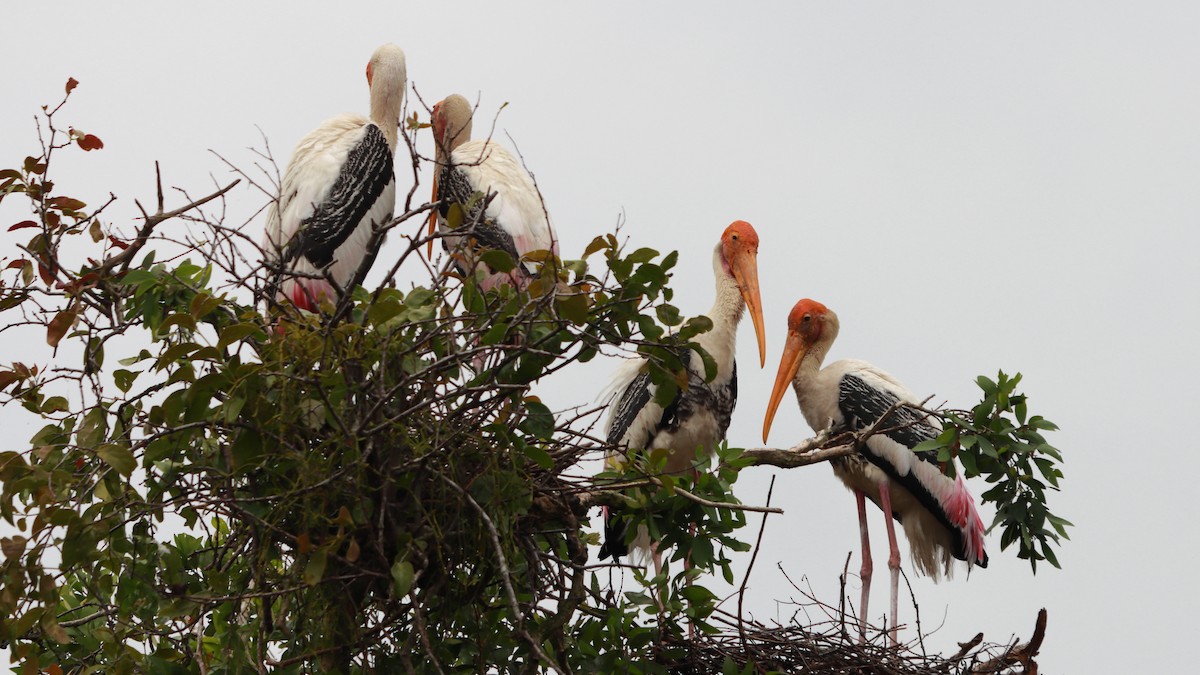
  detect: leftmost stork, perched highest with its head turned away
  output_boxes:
[264,44,407,311]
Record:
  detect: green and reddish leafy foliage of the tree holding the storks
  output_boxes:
[0,80,1068,673]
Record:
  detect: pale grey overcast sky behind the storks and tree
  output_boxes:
[0,1,1200,673]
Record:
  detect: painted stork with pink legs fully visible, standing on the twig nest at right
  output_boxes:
[762,299,988,644]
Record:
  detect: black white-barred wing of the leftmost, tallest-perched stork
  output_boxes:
[286,124,394,269]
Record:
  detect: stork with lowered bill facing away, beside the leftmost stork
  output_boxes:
[430,94,558,289]
